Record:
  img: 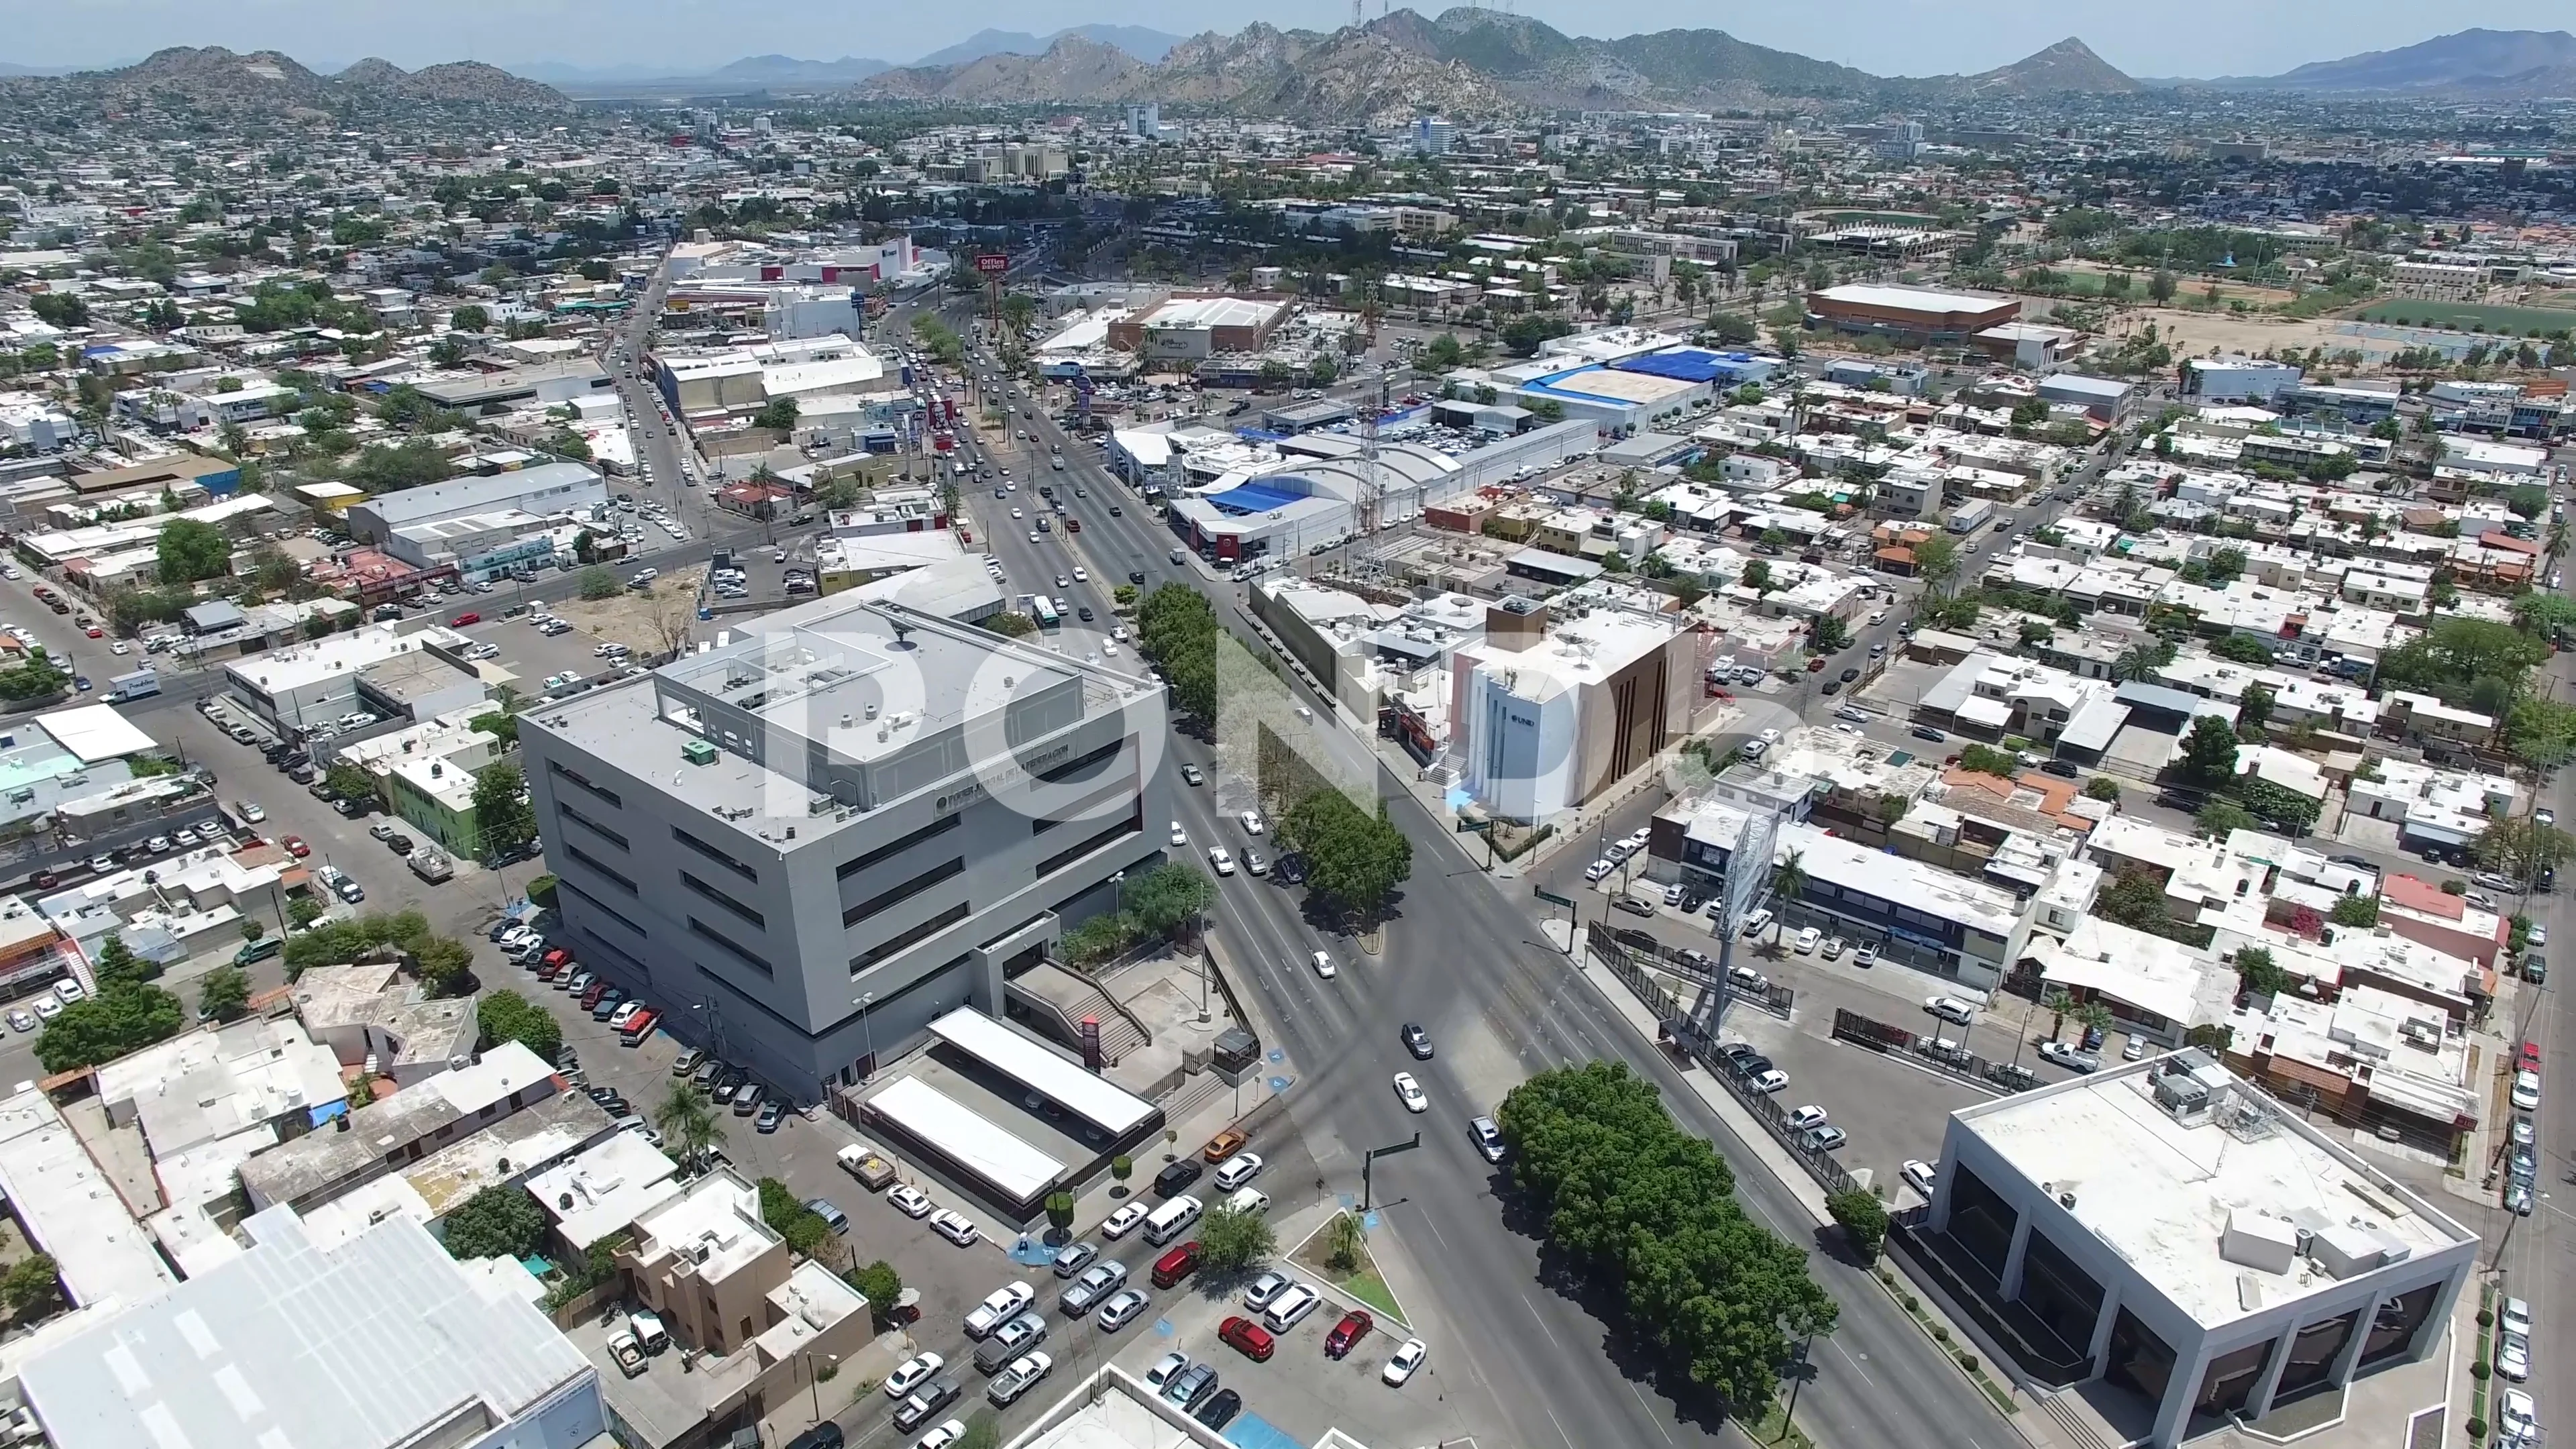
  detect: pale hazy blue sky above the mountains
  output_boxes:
[20,0,2576,74]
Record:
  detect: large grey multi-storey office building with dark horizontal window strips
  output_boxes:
[521,596,1169,1101]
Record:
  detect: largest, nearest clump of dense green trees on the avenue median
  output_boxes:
[1497,1062,1837,1421]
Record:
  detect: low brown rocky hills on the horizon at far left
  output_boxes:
[0,46,567,119]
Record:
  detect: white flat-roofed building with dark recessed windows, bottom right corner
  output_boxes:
[1927,1049,2478,1449]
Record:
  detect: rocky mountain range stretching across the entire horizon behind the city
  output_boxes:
[0,22,2576,123]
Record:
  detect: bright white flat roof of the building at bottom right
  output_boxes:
[1955,1055,2475,1328]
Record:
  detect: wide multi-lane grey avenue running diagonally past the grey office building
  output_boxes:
[906,301,2012,1449]
